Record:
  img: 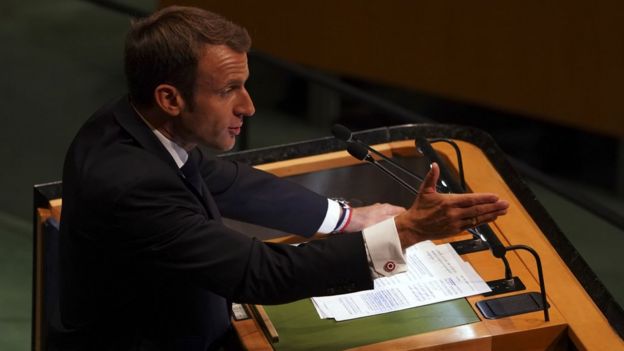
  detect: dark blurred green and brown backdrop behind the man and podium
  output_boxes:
[0,0,624,350]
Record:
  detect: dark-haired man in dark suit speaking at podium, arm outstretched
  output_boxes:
[56,7,507,350]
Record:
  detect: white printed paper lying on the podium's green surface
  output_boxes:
[312,241,490,321]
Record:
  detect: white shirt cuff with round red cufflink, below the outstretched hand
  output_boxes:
[362,218,407,278]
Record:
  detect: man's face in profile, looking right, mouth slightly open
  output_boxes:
[180,45,255,151]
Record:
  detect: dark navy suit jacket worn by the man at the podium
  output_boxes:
[56,97,372,350]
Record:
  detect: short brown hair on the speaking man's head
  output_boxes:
[124,6,251,106]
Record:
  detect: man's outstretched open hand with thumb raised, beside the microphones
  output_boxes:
[395,163,509,248]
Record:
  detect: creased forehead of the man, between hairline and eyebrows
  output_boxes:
[197,45,249,83]
